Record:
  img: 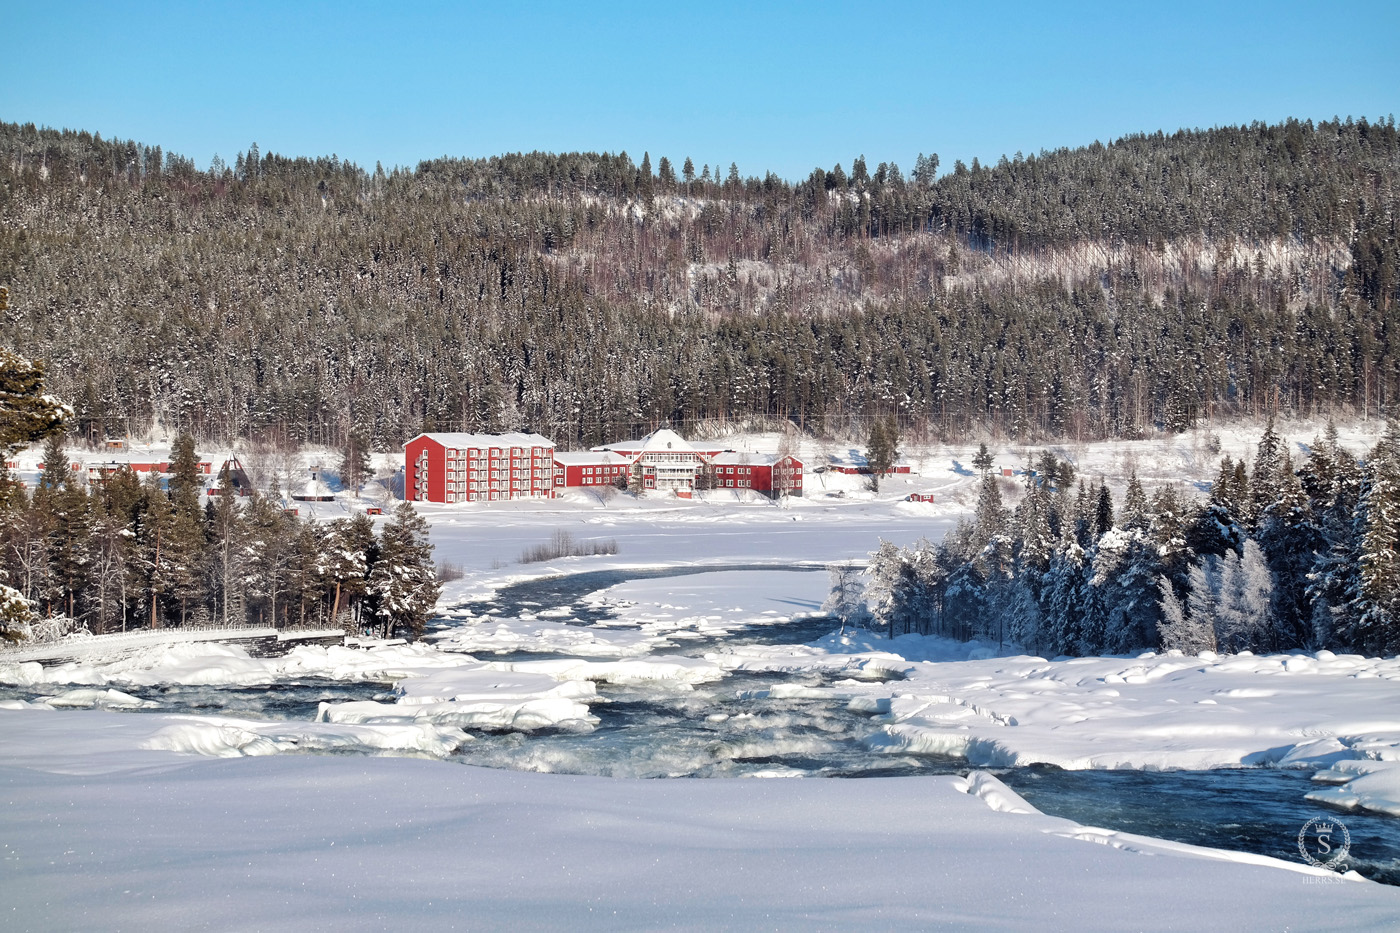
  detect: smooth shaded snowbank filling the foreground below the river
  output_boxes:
[0,750,1400,933]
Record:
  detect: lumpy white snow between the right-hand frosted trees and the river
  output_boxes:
[710,635,1400,815]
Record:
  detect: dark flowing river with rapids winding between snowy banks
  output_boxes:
[0,565,1400,884]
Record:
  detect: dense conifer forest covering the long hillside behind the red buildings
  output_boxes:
[0,118,1400,450]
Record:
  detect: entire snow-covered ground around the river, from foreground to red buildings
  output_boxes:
[0,424,1400,930]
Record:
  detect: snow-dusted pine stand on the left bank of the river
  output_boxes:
[0,426,441,643]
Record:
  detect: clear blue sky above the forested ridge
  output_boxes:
[0,0,1400,179]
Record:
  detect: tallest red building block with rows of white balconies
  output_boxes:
[403,433,554,503]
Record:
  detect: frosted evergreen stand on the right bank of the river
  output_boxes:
[867,419,1400,657]
